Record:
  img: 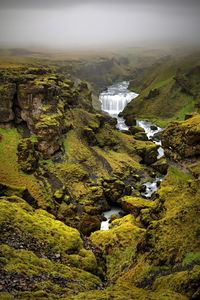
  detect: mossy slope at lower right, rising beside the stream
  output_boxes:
[118,167,200,295]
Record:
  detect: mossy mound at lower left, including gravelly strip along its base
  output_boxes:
[0,197,97,272]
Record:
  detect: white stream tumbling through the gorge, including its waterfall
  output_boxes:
[99,81,165,230]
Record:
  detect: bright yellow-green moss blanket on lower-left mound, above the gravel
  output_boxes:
[0,199,82,255]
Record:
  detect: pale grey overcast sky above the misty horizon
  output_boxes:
[0,0,200,48]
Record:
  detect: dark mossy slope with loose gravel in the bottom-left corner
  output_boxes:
[0,245,101,299]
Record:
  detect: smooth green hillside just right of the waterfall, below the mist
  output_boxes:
[123,53,200,127]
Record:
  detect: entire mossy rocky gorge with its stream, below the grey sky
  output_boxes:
[0,49,200,300]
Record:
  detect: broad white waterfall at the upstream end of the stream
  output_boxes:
[99,81,138,130]
